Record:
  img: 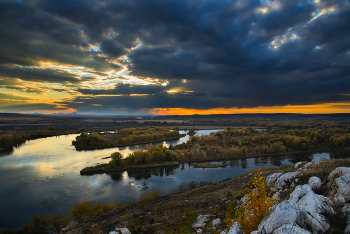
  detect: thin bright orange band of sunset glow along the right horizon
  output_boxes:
[150,103,350,115]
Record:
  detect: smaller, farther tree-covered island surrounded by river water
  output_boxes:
[72,126,184,150]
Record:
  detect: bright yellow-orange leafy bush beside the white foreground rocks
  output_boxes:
[226,171,274,233]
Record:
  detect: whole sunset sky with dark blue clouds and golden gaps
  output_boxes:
[0,0,350,115]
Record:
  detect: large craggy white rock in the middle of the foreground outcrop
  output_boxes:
[289,184,335,233]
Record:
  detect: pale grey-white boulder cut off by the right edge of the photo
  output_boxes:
[326,167,350,203]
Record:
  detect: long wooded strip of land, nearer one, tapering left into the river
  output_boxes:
[81,122,350,174]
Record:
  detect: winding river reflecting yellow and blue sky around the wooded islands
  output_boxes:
[0,130,347,231]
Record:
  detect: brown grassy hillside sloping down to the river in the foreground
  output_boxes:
[61,159,350,234]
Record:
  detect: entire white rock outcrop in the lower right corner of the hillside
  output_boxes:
[251,162,350,234]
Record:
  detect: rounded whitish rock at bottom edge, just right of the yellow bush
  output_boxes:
[257,200,306,234]
